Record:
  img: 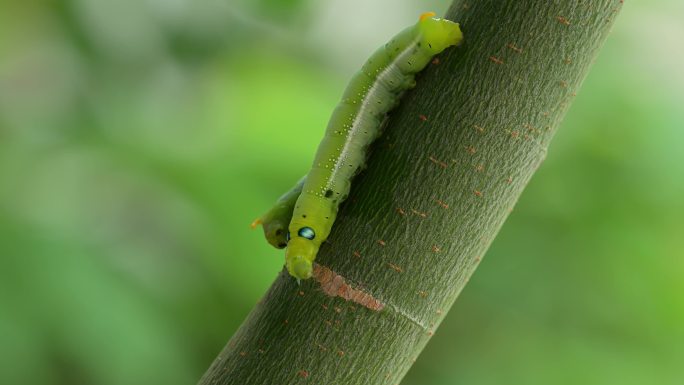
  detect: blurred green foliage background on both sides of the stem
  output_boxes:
[0,0,684,385]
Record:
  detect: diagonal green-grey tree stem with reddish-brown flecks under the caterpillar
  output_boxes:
[200,0,622,385]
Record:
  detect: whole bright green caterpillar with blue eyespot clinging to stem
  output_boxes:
[252,12,463,280]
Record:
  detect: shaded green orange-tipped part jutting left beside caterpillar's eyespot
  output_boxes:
[251,176,306,249]
